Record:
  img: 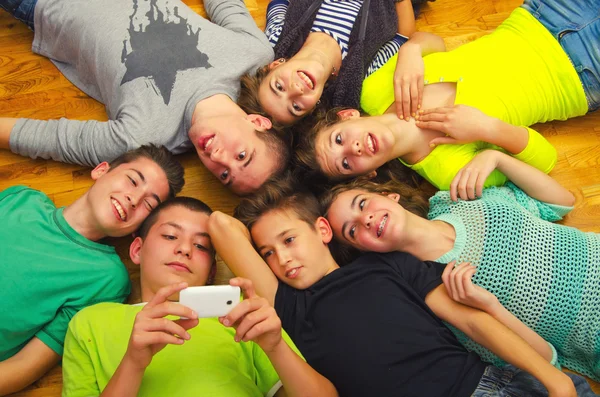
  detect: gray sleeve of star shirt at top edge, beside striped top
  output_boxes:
[204,0,264,36]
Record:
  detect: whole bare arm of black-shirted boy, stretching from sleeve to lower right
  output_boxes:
[425,285,577,396]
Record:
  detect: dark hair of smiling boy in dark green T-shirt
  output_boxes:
[109,144,185,197]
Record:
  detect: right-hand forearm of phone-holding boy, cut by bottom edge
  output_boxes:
[265,340,338,397]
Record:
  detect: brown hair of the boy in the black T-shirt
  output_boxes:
[233,172,321,230]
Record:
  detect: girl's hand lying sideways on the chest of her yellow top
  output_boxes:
[416,105,498,145]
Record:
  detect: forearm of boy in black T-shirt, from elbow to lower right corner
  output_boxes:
[461,311,572,392]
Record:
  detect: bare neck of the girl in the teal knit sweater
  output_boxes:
[396,212,456,261]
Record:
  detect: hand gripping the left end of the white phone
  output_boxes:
[124,283,198,370]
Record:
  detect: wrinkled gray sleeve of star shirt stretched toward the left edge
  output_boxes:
[9,118,141,167]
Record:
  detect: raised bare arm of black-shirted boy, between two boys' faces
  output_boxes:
[208,211,278,306]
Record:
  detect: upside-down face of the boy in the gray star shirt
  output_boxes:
[189,115,277,194]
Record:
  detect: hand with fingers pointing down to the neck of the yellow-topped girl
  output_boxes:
[394,42,425,120]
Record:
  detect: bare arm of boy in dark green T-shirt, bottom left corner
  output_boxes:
[0,337,60,396]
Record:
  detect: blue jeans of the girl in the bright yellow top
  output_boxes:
[523,0,600,111]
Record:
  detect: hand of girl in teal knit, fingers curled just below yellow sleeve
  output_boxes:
[450,150,502,201]
